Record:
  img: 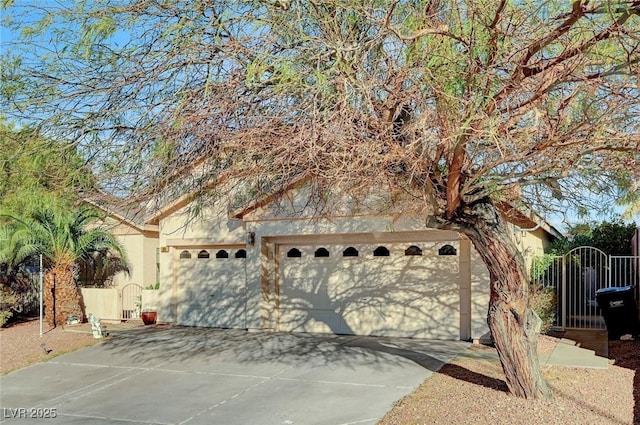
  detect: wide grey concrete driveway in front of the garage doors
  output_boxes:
[0,327,468,425]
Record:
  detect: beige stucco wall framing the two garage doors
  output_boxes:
[156,187,548,340]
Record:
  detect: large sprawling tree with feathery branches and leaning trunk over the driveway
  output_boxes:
[3,0,640,397]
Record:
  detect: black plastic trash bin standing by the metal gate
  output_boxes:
[596,286,640,339]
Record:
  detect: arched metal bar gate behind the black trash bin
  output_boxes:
[540,246,640,329]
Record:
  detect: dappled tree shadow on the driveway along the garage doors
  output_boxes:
[102,326,468,372]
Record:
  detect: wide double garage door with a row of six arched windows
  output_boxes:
[278,242,460,340]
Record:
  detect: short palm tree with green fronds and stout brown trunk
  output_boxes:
[0,207,126,326]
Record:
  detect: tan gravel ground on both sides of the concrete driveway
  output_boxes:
[0,320,640,425]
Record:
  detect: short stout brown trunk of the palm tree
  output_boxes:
[45,264,85,326]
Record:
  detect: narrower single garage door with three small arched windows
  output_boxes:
[177,249,246,328]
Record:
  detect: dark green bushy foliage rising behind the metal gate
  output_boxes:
[551,220,638,255]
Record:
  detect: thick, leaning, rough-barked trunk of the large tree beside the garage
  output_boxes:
[462,200,551,399]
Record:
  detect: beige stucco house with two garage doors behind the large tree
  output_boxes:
[94,184,558,340]
